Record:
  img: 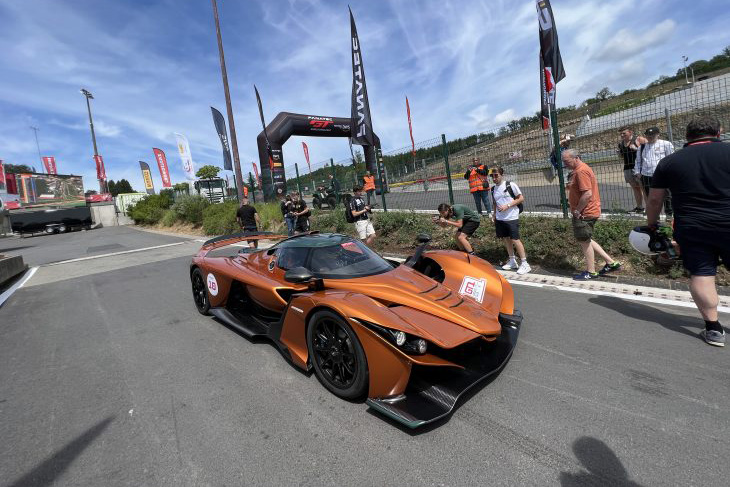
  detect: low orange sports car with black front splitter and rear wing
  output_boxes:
[190,232,522,428]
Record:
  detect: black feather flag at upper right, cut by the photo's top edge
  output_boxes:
[536,0,565,127]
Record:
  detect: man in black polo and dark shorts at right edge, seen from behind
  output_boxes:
[646,117,730,347]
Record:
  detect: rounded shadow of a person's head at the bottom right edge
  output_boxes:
[560,436,640,487]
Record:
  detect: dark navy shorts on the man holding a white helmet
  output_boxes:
[674,229,730,276]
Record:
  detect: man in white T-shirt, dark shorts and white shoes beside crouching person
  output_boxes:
[489,167,532,274]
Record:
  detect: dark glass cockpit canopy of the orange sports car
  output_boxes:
[277,234,393,279]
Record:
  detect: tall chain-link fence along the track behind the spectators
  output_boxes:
[287,73,730,213]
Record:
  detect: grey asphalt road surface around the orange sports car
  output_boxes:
[0,228,730,487]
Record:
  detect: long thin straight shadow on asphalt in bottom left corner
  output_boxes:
[8,416,114,487]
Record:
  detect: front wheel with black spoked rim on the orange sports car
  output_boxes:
[307,310,369,399]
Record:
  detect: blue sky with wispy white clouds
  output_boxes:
[0,0,730,193]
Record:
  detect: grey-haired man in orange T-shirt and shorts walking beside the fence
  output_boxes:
[562,149,621,281]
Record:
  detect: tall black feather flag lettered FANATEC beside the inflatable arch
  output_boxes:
[348,7,375,146]
